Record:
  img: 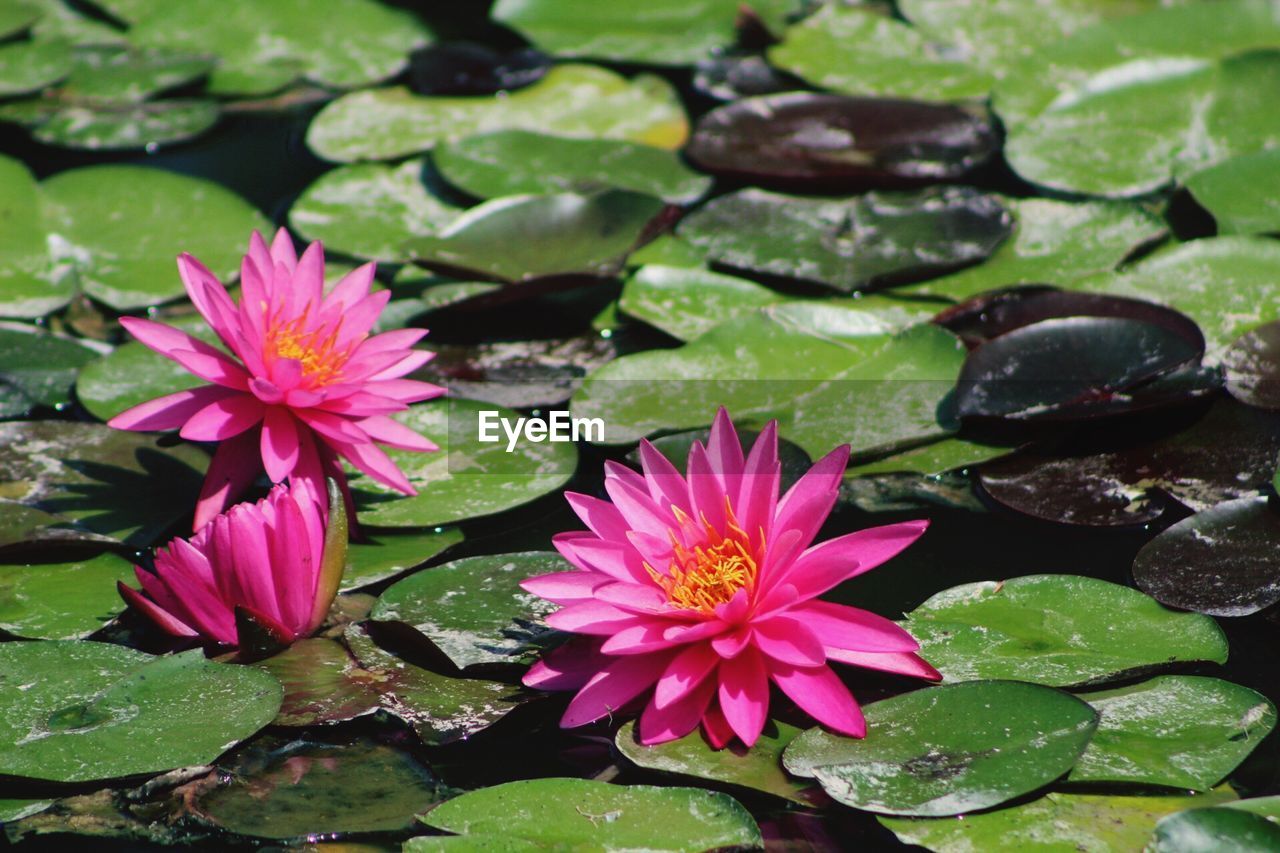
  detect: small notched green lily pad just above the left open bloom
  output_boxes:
[289,159,462,261]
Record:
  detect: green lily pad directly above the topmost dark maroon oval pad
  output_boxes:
[769,5,995,101]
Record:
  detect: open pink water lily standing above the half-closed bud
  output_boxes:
[109,228,444,530]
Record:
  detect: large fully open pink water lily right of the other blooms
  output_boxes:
[522,409,941,748]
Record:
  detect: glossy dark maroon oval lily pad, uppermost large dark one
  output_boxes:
[687,92,997,186]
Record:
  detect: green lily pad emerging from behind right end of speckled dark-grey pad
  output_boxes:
[904,199,1166,302]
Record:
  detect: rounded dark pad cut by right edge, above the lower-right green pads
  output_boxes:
[1133,497,1280,616]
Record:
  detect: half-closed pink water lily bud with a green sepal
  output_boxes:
[119,484,347,646]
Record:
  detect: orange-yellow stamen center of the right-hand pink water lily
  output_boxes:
[645,504,763,615]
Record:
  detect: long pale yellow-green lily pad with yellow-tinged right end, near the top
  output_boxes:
[307,64,689,163]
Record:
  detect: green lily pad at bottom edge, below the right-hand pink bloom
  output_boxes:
[420,779,764,852]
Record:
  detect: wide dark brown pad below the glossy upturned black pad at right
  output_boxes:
[978,400,1280,526]
